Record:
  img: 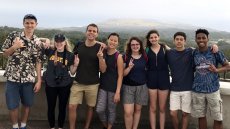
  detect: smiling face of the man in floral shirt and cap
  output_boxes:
[23,19,37,33]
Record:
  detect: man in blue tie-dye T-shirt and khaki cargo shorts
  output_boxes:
[192,29,230,129]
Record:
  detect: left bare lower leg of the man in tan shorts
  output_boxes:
[69,104,78,129]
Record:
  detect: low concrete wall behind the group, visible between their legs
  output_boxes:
[0,70,230,129]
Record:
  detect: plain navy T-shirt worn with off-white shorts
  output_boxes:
[167,48,194,91]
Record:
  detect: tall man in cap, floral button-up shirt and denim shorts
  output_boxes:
[2,14,49,129]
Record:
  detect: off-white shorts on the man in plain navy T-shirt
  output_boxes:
[170,91,192,113]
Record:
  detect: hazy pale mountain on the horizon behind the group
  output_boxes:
[59,19,230,40]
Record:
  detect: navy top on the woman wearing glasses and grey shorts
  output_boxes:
[123,55,147,86]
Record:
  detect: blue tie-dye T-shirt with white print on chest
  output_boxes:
[192,48,227,93]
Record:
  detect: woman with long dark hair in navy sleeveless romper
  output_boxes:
[146,30,170,129]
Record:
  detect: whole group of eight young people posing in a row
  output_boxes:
[2,14,230,129]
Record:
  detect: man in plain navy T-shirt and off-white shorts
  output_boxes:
[167,32,194,129]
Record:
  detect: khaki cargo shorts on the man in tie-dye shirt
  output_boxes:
[192,90,223,121]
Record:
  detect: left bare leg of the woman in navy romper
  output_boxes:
[149,89,157,129]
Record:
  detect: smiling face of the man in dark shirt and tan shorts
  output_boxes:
[86,26,98,41]
